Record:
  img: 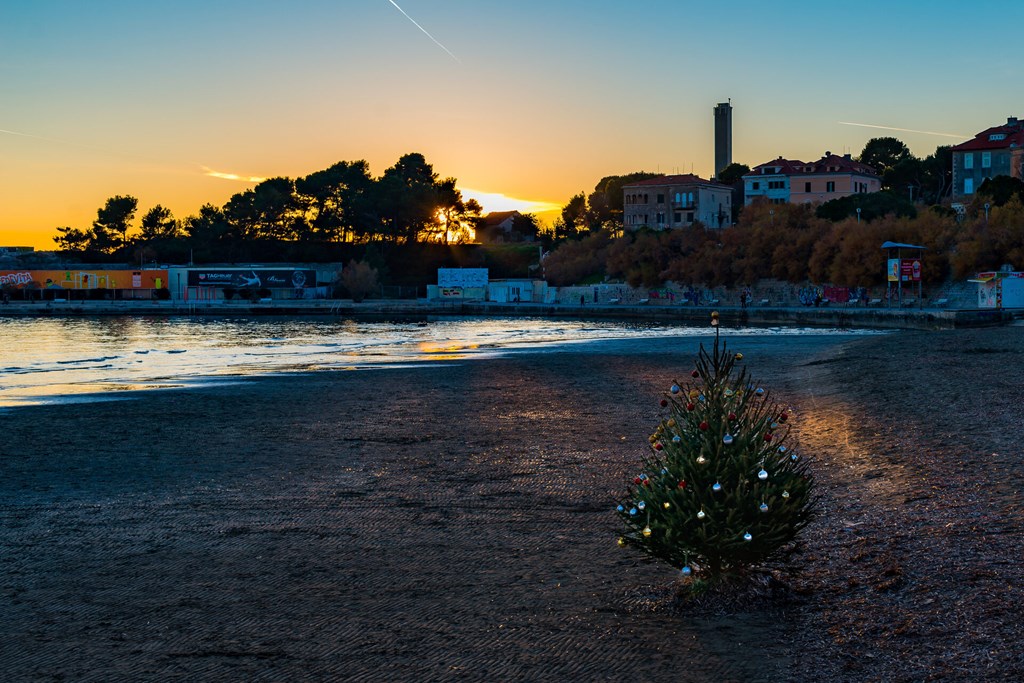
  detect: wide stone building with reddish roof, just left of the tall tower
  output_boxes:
[623,173,732,230]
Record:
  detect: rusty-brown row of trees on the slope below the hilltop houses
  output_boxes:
[544,181,1024,287]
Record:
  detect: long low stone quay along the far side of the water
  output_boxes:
[0,299,1011,330]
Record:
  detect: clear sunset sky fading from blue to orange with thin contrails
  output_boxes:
[0,0,1024,249]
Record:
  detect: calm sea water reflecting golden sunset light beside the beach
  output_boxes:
[0,317,879,408]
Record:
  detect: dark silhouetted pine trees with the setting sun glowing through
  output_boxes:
[54,154,481,258]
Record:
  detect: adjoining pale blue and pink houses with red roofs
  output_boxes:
[743,152,882,204]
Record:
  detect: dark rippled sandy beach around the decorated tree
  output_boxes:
[0,327,1024,681]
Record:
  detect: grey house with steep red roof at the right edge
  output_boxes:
[952,117,1024,201]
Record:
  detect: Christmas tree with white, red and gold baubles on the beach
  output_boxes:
[617,312,813,586]
